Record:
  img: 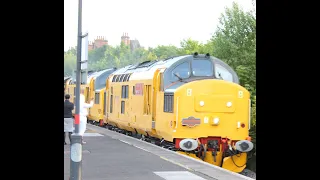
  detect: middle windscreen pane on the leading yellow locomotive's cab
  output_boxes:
[192,60,213,76]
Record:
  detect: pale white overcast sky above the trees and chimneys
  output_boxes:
[64,0,253,51]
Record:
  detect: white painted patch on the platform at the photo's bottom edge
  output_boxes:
[153,171,206,180]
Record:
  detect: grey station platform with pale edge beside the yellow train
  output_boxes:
[64,124,253,180]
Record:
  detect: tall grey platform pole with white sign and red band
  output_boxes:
[70,0,88,180]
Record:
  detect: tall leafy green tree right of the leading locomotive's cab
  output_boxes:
[208,3,256,171]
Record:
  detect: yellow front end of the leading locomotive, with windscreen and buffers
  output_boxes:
[157,55,253,172]
